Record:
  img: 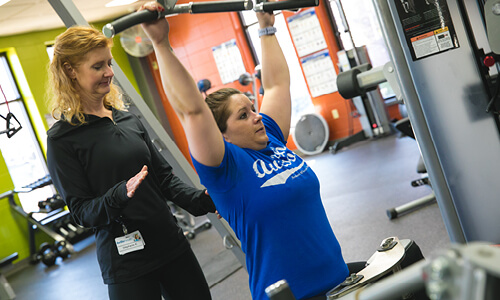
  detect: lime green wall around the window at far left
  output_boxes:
[0,22,140,261]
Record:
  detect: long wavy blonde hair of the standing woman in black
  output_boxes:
[47,26,125,125]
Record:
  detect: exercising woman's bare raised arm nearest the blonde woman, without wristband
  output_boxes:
[141,2,224,166]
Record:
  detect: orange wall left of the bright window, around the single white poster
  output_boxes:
[148,13,255,161]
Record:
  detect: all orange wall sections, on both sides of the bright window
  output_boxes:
[148,0,399,161]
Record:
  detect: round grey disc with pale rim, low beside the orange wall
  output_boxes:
[292,113,330,155]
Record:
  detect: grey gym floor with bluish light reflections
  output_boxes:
[5,134,450,300]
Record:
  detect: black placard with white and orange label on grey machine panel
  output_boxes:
[395,0,459,61]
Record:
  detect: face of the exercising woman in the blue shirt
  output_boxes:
[223,94,269,150]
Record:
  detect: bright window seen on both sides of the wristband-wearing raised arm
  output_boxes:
[241,11,314,128]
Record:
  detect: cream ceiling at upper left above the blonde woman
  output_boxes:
[0,0,146,36]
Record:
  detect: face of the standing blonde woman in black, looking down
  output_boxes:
[71,47,115,100]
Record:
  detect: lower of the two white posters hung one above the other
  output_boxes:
[301,50,337,97]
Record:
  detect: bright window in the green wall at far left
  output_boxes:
[0,54,54,212]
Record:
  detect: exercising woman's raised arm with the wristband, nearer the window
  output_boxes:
[257,13,292,140]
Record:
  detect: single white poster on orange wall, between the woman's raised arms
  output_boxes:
[212,39,246,84]
